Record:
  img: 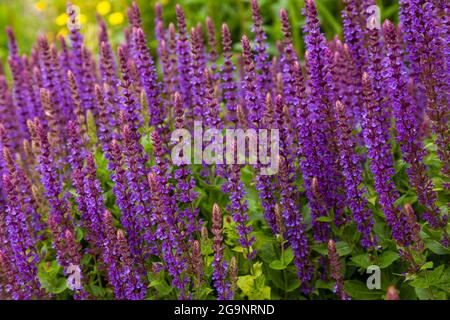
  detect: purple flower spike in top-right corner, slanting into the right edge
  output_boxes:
[400,0,450,177]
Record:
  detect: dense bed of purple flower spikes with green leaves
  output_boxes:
[0,0,450,300]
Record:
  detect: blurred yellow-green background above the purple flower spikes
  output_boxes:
[0,0,397,69]
